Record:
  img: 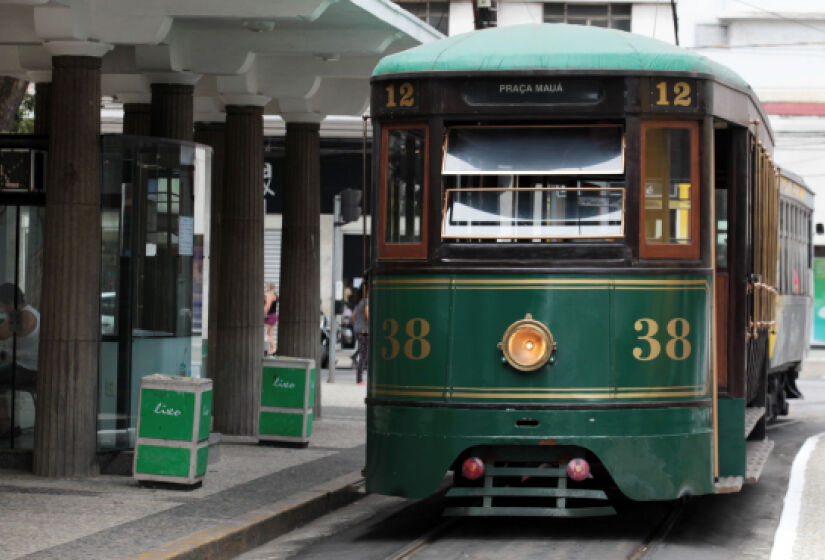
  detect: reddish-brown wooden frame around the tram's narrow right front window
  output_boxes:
[639,121,696,259]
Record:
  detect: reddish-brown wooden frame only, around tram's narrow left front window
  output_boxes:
[378,122,430,260]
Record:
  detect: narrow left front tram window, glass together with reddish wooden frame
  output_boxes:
[379,125,427,258]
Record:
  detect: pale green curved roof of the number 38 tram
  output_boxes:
[373,23,749,89]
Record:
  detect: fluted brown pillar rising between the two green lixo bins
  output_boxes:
[209,104,262,436]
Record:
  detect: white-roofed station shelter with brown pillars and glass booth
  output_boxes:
[0,0,442,477]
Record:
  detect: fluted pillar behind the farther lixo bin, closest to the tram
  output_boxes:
[278,122,321,394]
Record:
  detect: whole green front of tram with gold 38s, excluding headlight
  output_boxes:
[367,275,713,500]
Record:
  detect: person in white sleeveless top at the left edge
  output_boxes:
[0,283,40,438]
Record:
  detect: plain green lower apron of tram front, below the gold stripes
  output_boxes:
[366,405,713,500]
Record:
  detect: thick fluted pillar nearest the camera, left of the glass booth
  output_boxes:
[34,51,111,477]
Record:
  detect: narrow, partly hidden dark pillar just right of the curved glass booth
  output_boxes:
[195,122,226,377]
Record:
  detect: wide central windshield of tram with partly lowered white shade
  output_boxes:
[441,125,625,242]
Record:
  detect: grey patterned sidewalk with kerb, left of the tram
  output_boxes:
[0,359,366,559]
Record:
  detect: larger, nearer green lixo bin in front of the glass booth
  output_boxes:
[133,374,212,484]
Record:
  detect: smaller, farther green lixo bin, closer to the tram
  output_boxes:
[258,356,315,445]
